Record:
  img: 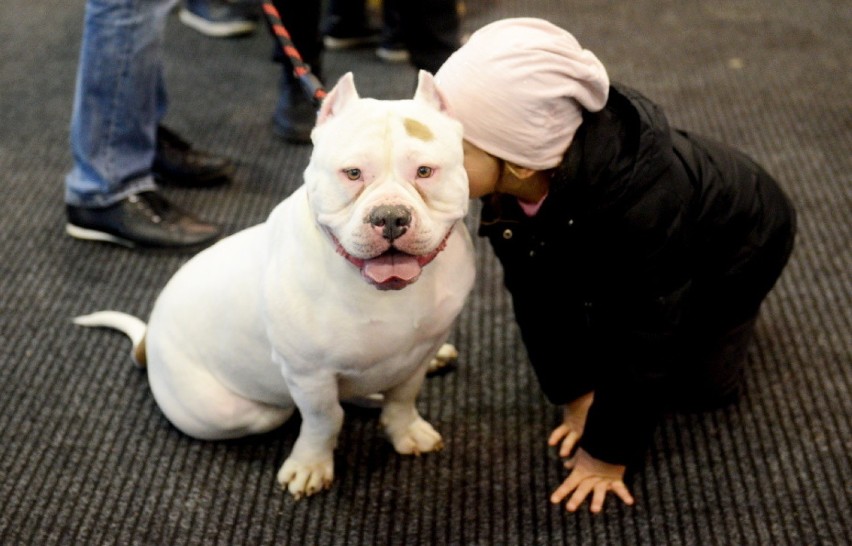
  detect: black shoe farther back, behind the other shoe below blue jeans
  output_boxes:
[151,125,234,188]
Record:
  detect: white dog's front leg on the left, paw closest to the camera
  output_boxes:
[278,352,343,500]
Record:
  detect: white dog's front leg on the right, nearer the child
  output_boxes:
[381,367,444,455]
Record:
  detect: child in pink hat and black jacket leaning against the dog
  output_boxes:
[436,18,795,512]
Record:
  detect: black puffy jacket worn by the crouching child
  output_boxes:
[479,84,795,464]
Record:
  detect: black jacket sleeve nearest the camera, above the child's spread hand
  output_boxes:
[580,160,693,465]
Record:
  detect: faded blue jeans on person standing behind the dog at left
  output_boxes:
[65,0,177,207]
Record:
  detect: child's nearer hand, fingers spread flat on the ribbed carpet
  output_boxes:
[550,449,633,514]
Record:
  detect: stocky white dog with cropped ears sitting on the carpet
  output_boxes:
[75,72,474,498]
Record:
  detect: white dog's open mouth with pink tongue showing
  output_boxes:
[329,230,452,290]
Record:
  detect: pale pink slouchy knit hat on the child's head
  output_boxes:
[435,18,609,170]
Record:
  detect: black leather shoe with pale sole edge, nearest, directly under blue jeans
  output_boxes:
[65,191,220,248]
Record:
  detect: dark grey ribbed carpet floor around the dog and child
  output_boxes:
[0,0,852,546]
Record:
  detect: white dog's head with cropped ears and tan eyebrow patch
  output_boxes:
[305,71,468,289]
